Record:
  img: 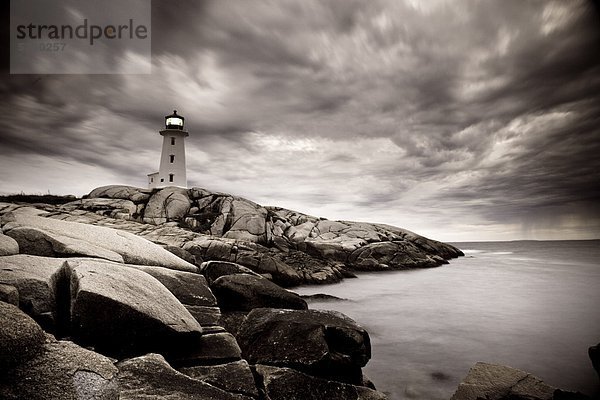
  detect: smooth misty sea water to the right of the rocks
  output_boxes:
[295,241,600,400]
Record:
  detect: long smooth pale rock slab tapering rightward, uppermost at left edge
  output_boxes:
[3,209,198,272]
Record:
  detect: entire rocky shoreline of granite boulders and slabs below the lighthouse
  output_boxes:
[0,186,596,400]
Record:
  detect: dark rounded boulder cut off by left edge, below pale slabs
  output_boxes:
[0,302,46,371]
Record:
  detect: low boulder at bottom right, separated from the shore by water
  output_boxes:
[451,362,556,400]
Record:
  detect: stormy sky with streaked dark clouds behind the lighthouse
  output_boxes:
[0,0,600,241]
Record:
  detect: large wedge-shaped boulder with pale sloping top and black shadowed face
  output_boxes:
[69,259,202,357]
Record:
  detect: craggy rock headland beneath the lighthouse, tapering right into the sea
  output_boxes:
[75,187,462,286]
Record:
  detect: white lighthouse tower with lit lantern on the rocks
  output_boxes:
[148,110,190,189]
